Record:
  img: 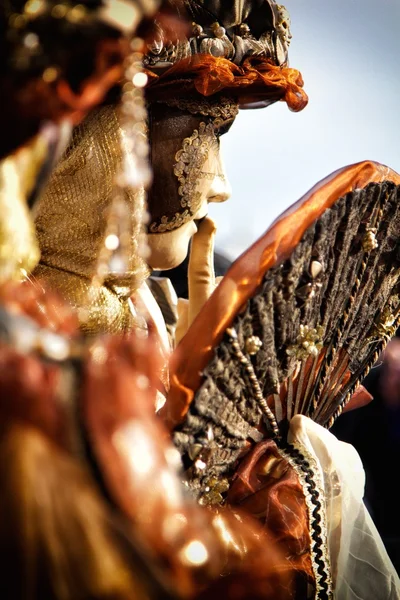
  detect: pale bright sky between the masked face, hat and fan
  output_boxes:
[210,0,400,258]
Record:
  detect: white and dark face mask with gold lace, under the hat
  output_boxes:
[148,99,238,268]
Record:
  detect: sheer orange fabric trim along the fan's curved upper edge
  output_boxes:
[160,161,400,429]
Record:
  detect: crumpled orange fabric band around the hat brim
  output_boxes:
[146,54,308,112]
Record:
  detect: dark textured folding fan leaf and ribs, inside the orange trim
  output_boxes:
[169,166,400,496]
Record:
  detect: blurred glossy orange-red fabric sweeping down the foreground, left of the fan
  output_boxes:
[80,335,297,600]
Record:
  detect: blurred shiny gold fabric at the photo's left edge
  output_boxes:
[0,136,47,282]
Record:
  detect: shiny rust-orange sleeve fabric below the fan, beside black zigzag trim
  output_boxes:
[228,440,314,599]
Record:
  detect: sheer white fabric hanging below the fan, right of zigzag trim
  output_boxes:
[288,415,400,600]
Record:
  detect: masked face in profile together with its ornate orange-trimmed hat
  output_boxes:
[144,0,307,269]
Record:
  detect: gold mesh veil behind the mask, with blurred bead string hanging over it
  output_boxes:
[35,42,150,333]
